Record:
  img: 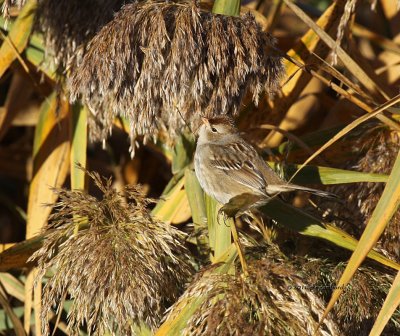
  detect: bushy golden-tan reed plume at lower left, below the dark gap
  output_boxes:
[32,173,191,335]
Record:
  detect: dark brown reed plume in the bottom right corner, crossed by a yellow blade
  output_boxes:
[296,257,400,336]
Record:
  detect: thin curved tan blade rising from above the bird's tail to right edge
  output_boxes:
[290,95,400,181]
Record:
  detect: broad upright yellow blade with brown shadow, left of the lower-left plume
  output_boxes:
[24,93,69,332]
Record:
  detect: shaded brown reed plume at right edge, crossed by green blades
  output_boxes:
[325,122,400,261]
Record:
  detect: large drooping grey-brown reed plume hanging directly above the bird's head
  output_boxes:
[70,1,282,150]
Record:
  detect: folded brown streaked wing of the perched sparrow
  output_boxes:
[210,142,266,193]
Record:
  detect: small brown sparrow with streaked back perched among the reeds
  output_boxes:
[194,116,333,204]
